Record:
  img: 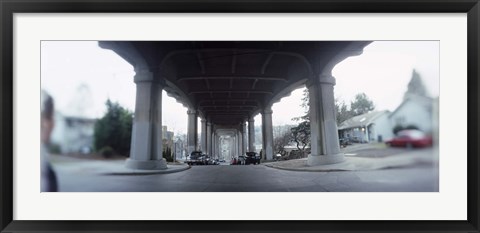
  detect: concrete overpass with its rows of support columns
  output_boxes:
[99,41,371,169]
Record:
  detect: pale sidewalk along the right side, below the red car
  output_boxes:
[264,149,438,172]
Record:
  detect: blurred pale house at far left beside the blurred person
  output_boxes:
[51,112,96,154]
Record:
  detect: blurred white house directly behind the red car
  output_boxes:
[390,95,435,133]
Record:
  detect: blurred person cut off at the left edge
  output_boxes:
[40,90,57,192]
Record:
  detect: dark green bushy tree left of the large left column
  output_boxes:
[94,100,133,156]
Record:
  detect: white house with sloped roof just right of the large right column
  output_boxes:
[338,110,394,142]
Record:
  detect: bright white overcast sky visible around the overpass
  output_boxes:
[41,41,440,133]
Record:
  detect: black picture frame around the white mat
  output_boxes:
[0,0,480,233]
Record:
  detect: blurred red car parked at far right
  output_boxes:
[385,129,433,148]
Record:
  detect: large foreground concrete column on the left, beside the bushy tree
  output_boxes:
[125,70,167,170]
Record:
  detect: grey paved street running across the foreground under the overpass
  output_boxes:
[55,146,438,192]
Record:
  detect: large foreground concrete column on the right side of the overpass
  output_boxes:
[307,75,345,166]
